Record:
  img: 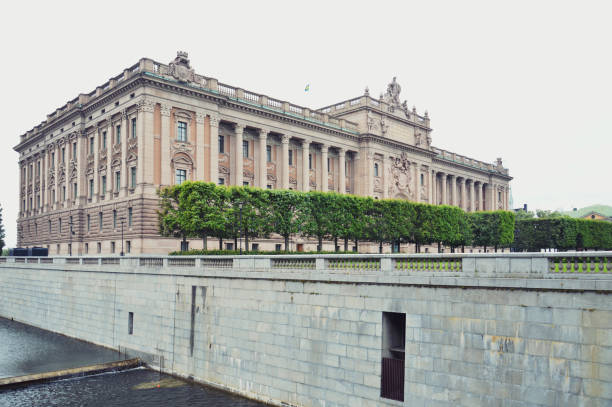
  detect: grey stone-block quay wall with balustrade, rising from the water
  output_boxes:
[0,252,612,407]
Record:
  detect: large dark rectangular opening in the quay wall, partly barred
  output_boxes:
[380,312,406,401]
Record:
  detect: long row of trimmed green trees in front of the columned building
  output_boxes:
[159,182,514,251]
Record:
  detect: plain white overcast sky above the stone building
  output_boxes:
[0,0,612,246]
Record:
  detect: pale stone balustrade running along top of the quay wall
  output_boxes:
[0,252,612,277]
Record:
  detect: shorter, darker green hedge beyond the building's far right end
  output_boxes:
[512,217,612,252]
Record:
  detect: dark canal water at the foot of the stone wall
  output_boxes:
[0,318,264,407]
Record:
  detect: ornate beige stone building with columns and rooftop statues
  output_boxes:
[15,52,511,254]
